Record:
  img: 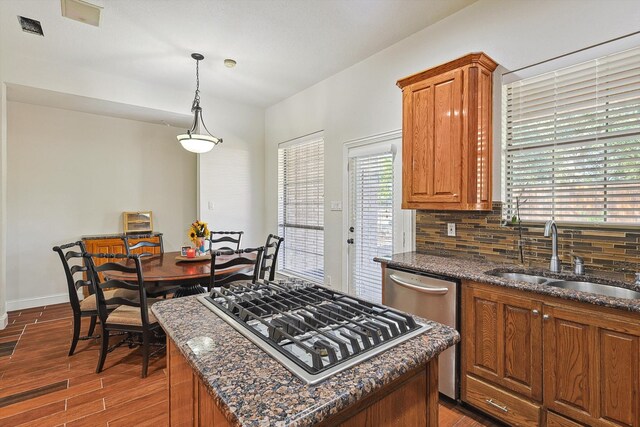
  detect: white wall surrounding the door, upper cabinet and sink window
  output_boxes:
[265,0,640,287]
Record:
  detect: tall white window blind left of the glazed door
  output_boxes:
[278,138,324,283]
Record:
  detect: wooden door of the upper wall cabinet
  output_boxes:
[402,69,463,207]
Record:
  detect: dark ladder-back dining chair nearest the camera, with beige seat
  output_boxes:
[85,254,161,378]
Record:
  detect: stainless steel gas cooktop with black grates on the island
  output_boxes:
[198,279,431,384]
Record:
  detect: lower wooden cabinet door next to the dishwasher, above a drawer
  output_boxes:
[462,288,542,401]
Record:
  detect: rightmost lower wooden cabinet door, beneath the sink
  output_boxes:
[544,306,640,426]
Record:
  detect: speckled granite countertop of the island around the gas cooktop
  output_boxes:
[152,296,460,426]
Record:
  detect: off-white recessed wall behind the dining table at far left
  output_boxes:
[7,102,197,310]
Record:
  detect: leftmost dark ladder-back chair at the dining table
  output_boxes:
[53,241,100,356]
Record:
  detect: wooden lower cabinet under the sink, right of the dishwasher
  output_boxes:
[462,282,640,427]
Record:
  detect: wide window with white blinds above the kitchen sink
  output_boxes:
[504,48,640,224]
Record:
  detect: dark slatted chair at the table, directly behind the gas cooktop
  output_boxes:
[208,247,264,291]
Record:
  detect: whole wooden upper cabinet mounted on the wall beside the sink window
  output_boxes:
[398,53,497,210]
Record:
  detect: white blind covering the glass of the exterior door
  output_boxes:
[349,152,393,303]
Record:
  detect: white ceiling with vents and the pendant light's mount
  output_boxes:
[0,0,475,107]
